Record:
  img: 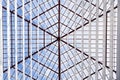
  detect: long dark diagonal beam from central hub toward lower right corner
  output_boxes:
[61,40,116,73]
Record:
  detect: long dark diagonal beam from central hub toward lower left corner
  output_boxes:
[3,40,57,73]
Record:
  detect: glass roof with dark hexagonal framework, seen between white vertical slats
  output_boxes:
[2,0,117,80]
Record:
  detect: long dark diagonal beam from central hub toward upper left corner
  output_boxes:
[2,6,57,38]
